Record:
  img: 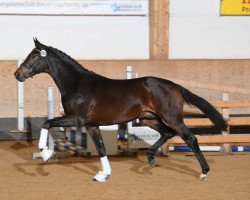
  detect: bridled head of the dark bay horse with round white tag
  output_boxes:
[14,38,49,82]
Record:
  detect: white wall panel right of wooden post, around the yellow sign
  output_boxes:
[169,0,250,59]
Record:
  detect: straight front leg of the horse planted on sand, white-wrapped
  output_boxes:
[86,127,111,182]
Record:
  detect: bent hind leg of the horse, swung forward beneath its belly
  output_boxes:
[141,119,176,167]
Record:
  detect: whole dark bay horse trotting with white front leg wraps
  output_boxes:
[15,38,227,181]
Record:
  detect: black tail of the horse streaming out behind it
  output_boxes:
[178,85,228,131]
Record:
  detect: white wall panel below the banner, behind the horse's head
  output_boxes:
[0,15,149,60]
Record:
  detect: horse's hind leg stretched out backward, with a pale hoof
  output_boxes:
[170,123,209,180]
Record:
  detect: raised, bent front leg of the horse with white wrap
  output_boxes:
[38,116,77,161]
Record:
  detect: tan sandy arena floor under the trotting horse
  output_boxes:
[0,140,250,200]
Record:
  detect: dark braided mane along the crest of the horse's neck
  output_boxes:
[48,46,98,75]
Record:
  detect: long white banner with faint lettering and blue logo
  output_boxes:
[0,0,148,15]
